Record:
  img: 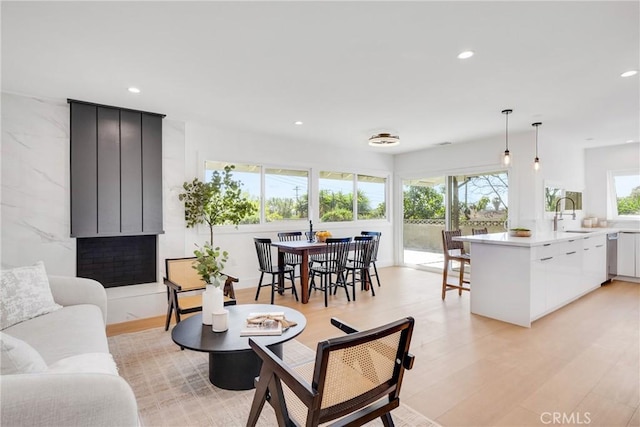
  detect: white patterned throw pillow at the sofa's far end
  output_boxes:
[0,261,62,330]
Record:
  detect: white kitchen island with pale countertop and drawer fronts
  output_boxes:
[456,229,611,327]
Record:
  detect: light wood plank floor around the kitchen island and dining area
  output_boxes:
[109,267,640,427]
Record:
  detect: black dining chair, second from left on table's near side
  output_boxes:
[309,237,351,307]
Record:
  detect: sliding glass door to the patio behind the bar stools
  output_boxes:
[402,171,509,270]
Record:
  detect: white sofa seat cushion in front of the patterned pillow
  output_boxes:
[4,304,109,365]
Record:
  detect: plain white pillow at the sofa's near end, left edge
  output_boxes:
[0,332,47,375]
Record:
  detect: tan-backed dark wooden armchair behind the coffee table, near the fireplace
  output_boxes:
[164,257,238,331]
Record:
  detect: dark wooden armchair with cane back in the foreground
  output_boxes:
[247,317,414,426]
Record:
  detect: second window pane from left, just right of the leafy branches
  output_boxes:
[264,168,309,222]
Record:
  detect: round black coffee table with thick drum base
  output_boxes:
[171,304,307,390]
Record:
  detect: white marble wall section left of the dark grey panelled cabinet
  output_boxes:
[0,93,76,275]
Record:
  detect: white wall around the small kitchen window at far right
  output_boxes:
[585,142,640,227]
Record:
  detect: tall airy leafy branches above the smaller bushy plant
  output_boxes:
[178,165,256,244]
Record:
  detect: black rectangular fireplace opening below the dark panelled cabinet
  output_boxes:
[76,235,157,288]
